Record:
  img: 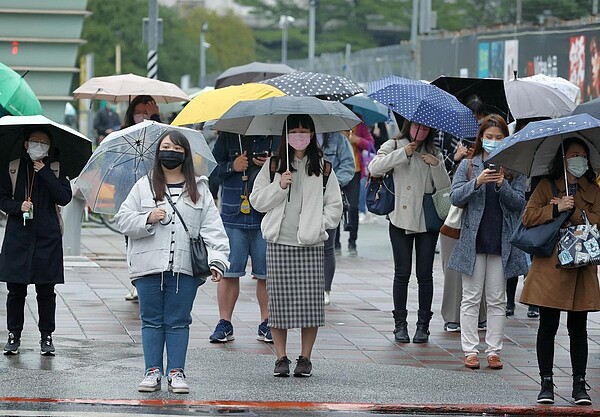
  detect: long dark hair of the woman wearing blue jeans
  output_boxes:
[152,130,200,203]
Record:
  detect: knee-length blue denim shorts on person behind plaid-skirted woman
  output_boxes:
[224,226,267,279]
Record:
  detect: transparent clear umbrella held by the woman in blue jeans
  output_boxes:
[75,120,217,214]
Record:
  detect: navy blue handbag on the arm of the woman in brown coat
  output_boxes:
[510,181,569,258]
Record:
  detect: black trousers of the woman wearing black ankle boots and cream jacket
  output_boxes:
[389,223,438,311]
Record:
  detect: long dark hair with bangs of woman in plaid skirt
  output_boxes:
[277,114,323,177]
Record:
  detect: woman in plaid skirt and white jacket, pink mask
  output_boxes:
[250,115,342,377]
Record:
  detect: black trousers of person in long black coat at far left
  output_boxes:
[6,283,56,338]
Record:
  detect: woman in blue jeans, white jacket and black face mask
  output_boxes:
[116,130,229,394]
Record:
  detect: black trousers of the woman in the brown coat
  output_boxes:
[536,307,588,377]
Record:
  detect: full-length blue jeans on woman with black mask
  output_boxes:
[134,272,200,375]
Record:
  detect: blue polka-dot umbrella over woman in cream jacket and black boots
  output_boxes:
[368,75,479,138]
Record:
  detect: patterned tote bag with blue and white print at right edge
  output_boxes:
[558,210,600,268]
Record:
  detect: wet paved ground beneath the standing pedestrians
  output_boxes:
[0,219,600,416]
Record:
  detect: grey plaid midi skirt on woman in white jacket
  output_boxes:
[267,243,325,329]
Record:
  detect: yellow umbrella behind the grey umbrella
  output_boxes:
[171,83,285,126]
